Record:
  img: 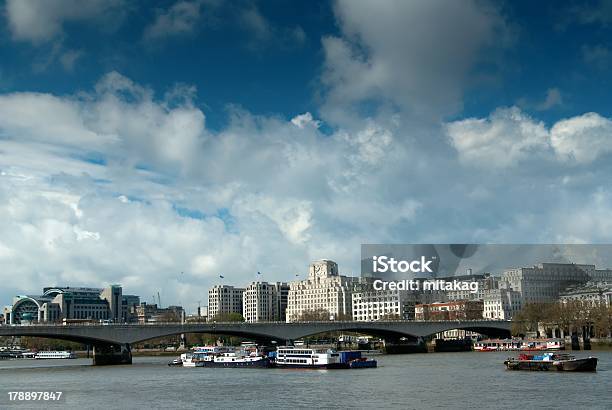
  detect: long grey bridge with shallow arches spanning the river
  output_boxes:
[0,320,511,365]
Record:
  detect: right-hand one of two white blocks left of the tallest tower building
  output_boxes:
[242,282,289,322]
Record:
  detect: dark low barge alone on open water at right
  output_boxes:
[504,353,597,372]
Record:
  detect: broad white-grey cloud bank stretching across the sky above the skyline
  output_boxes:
[0,72,610,310]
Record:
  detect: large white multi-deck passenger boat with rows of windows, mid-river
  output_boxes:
[276,346,346,369]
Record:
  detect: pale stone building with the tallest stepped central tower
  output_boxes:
[286,259,358,322]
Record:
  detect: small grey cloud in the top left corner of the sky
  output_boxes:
[5,0,123,44]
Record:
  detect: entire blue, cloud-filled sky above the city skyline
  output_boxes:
[0,0,612,311]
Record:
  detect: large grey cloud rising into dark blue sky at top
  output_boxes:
[322,0,509,120]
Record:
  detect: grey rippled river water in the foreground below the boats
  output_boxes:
[0,351,612,409]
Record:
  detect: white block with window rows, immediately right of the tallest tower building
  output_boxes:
[352,289,415,321]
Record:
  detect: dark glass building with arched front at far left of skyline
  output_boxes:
[4,285,140,324]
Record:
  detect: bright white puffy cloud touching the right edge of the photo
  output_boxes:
[550,112,612,164]
